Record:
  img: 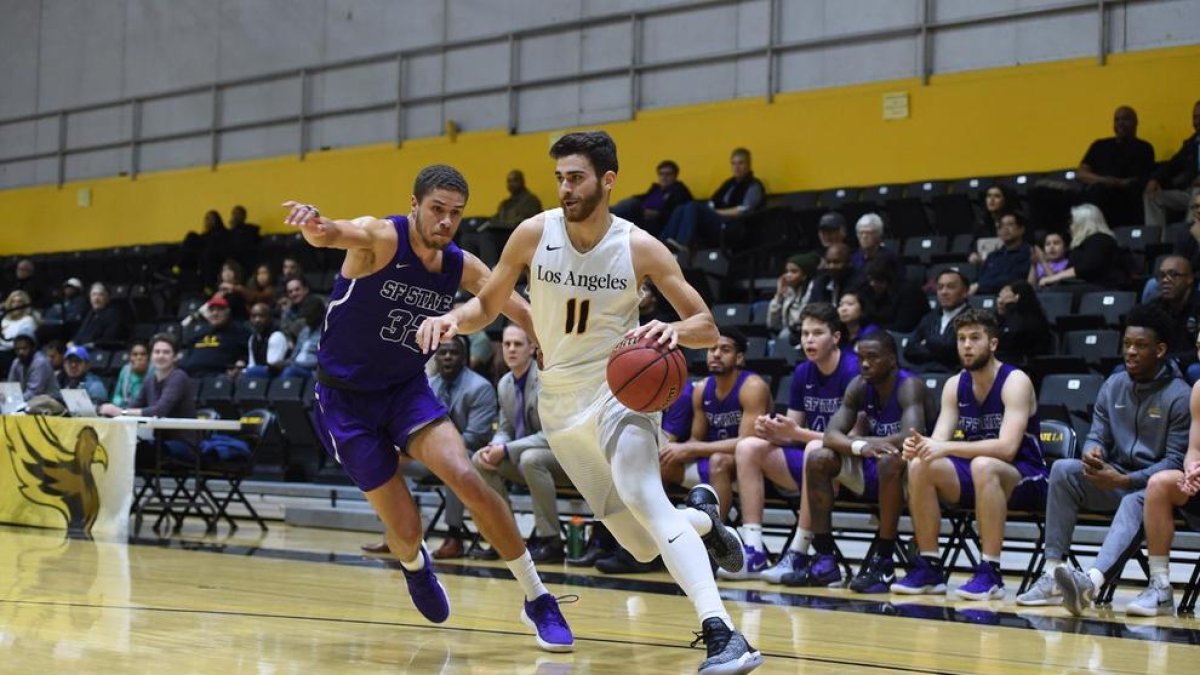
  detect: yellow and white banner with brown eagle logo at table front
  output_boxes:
[0,414,136,534]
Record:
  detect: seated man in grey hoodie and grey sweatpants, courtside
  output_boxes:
[1041,305,1192,616]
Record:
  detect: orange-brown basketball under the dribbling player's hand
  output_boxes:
[608,339,688,412]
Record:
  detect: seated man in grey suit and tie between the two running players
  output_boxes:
[470,324,570,562]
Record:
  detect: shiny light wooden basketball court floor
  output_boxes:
[0,525,1200,675]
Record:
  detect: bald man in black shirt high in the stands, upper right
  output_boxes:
[1075,106,1152,226]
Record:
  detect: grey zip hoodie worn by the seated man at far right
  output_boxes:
[1084,362,1192,490]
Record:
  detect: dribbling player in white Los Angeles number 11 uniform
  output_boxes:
[418,132,762,675]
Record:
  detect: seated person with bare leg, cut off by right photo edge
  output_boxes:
[1126,384,1200,616]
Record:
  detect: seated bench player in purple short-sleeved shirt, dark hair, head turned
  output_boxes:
[734,303,858,584]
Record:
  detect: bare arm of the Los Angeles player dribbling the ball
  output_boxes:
[629,229,718,350]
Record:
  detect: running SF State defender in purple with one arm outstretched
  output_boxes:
[283,165,575,651]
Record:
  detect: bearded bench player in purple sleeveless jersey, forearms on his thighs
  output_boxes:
[892,309,1049,601]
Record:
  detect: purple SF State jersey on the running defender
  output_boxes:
[317,216,463,392]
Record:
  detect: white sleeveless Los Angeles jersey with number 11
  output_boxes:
[529,209,640,392]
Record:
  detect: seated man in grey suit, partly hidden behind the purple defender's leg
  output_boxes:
[403,335,497,560]
